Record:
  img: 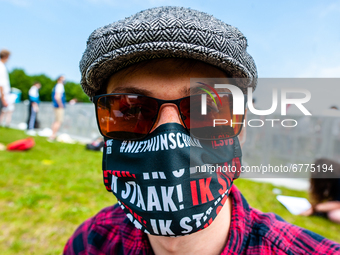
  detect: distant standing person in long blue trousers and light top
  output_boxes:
[27,82,41,135]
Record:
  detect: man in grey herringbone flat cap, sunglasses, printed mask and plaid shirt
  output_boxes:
[64,7,340,255]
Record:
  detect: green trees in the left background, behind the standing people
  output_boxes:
[9,69,90,102]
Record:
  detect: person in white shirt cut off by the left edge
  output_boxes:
[0,50,14,125]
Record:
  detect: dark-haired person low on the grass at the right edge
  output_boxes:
[301,158,340,224]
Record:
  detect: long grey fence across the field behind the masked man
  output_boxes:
[7,102,340,171]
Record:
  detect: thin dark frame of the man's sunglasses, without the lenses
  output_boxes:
[90,92,247,141]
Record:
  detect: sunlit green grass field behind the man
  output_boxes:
[0,128,340,255]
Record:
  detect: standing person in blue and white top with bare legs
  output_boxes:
[48,75,66,141]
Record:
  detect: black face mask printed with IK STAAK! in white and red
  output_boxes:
[103,123,241,236]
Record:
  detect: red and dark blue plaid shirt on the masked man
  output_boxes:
[64,185,340,255]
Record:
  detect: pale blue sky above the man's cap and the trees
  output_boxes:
[0,0,340,82]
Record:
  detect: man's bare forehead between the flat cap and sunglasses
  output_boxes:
[107,58,231,95]
